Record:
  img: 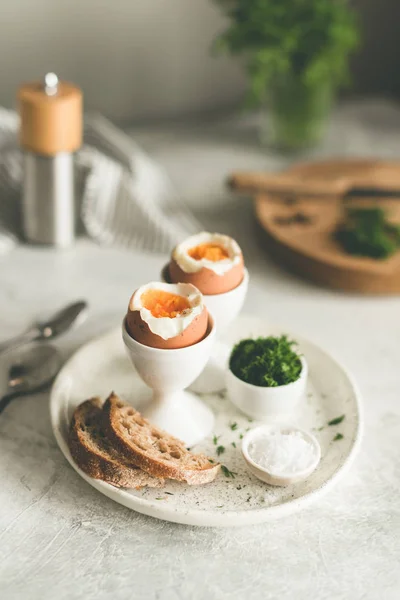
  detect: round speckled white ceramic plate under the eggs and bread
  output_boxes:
[50,317,361,527]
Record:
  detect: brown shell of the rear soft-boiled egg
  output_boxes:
[169,256,244,296]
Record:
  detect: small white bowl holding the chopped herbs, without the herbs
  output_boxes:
[226,356,308,421]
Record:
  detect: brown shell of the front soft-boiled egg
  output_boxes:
[126,307,208,350]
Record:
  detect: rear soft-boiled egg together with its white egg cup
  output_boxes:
[162,231,249,393]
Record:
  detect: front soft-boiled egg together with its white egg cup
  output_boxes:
[122,282,215,446]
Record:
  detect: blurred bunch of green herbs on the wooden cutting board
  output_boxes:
[334,207,400,259]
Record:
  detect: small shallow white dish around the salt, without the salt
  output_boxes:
[242,425,321,487]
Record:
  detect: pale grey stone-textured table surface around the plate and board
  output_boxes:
[0,102,400,600]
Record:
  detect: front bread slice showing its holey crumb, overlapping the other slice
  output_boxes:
[103,393,220,485]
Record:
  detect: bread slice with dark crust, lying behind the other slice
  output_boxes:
[68,398,164,488]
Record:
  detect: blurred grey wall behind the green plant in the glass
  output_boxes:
[0,0,400,121]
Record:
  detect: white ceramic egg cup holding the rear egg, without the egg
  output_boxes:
[161,265,249,394]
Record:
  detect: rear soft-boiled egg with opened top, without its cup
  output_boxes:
[169,231,244,295]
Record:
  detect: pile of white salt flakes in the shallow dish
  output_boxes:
[249,430,317,475]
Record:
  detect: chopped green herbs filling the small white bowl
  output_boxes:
[229,335,301,387]
